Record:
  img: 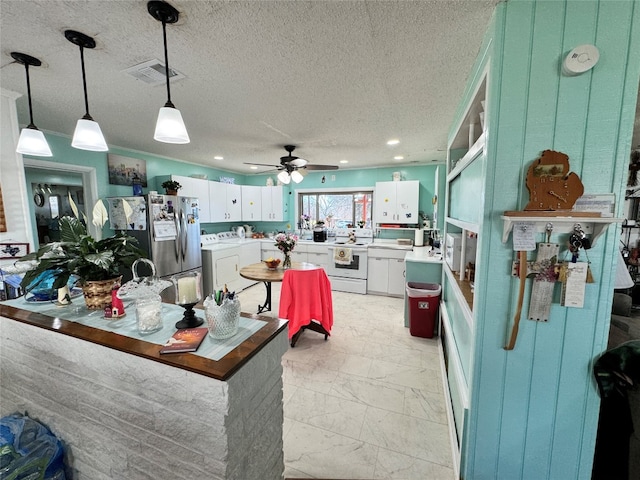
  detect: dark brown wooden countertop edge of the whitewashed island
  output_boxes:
[0,304,288,381]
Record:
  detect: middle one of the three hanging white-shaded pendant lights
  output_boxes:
[64,30,109,152]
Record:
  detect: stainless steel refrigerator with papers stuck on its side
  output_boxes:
[108,195,202,277]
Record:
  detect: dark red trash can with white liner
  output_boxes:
[407,282,442,338]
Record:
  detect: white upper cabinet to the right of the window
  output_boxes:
[373,180,420,224]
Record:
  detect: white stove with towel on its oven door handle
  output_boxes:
[327,228,373,295]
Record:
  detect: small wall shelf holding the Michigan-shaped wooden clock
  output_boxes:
[500,212,624,245]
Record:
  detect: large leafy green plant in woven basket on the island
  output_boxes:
[17,216,147,309]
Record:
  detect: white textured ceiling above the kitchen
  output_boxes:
[10,0,636,173]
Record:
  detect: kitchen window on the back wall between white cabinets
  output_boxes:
[298,191,373,228]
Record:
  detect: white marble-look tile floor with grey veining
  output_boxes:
[240,283,454,480]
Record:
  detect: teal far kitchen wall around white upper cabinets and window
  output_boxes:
[27,133,443,238]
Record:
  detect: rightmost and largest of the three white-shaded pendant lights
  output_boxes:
[147,0,191,143]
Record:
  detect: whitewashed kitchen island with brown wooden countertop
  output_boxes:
[0,299,288,480]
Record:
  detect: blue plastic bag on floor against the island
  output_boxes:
[0,413,66,480]
